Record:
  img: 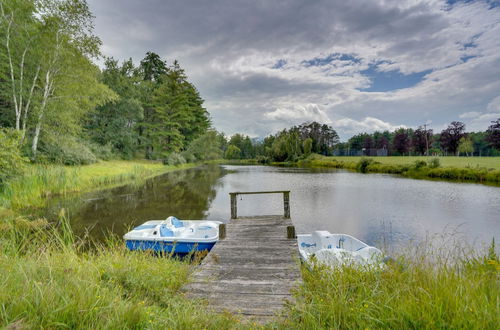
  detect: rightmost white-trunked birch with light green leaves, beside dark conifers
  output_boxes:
[31,0,114,159]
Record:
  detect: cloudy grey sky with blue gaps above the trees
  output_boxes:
[89,0,500,139]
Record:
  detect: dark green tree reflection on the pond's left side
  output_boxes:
[46,165,227,239]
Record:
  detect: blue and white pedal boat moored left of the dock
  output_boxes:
[123,216,222,254]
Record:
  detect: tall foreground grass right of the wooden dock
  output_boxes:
[281,237,500,329]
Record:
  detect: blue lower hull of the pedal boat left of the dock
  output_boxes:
[125,240,216,254]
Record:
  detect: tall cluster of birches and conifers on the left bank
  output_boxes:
[0,0,211,179]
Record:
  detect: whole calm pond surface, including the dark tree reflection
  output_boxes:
[47,166,500,251]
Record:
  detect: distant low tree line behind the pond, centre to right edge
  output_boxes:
[222,118,500,162]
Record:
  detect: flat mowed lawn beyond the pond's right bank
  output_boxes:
[326,156,500,170]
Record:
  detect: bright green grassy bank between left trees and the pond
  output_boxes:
[0,161,195,210]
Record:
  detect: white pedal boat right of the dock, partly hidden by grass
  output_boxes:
[297,230,384,268]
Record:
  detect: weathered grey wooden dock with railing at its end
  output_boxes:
[185,192,300,322]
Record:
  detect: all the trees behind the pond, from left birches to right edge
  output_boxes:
[0,0,500,186]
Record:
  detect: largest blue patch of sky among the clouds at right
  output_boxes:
[360,65,432,92]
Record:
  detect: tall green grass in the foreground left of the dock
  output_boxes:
[0,216,235,329]
